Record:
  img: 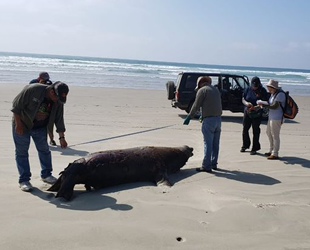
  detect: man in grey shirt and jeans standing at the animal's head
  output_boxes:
[183,76,222,173]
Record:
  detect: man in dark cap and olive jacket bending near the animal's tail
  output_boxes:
[11,82,69,191]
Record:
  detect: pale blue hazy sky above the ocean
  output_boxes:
[0,0,310,69]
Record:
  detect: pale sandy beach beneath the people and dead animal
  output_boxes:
[0,84,310,250]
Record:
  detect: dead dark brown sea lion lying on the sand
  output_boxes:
[48,146,193,200]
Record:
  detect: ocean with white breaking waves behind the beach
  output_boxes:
[0,52,310,92]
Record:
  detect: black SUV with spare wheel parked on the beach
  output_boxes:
[166,72,250,113]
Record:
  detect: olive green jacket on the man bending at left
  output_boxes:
[11,83,66,133]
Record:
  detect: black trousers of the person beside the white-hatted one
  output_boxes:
[242,113,262,151]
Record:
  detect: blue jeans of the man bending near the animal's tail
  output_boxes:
[13,125,53,183]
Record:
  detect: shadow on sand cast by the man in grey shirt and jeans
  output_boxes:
[213,169,281,185]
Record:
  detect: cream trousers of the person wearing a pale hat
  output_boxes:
[266,120,282,156]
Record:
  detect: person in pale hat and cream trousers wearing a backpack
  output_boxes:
[258,79,286,160]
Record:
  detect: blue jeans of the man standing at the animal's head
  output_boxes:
[201,116,222,170]
